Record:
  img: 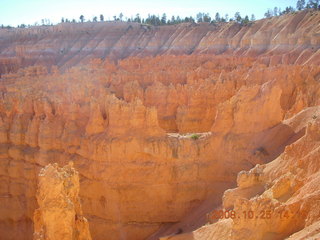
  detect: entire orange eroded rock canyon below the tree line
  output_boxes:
[0,10,320,240]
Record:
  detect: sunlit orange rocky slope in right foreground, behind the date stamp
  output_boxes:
[162,106,320,240]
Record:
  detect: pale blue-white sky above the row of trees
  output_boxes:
[0,0,297,26]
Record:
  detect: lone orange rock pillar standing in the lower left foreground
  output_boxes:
[33,163,91,240]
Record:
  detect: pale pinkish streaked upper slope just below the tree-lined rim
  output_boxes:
[0,11,320,74]
